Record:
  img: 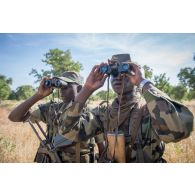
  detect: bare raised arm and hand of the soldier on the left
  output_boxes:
[8,77,53,122]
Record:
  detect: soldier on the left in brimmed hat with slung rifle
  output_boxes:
[9,71,104,162]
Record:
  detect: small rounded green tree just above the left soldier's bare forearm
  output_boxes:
[15,85,35,100]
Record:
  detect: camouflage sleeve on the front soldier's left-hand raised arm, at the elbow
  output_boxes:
[59,102,101,140]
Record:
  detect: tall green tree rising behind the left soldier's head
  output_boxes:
[29,49,83,82]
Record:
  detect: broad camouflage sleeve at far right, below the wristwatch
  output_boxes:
[143,86,193,143]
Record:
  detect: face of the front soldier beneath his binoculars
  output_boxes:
[111,74,134,94]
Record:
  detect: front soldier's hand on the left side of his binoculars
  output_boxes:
[84,63,107,92]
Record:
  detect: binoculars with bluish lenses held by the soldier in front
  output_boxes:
[100,62,130,77]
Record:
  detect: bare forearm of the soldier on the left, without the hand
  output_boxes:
[8,93,42,122]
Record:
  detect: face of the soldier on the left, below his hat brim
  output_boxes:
[60,83,78,102]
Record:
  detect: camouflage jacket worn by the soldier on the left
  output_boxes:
[30,102,104,162]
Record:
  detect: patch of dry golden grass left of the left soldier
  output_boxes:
[0,102,42,162]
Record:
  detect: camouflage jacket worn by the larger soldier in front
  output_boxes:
[60,86,193,162]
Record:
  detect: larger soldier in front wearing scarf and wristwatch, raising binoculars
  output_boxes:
[60,54,193,162]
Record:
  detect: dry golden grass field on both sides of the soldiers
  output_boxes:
[0,101,195,162]
